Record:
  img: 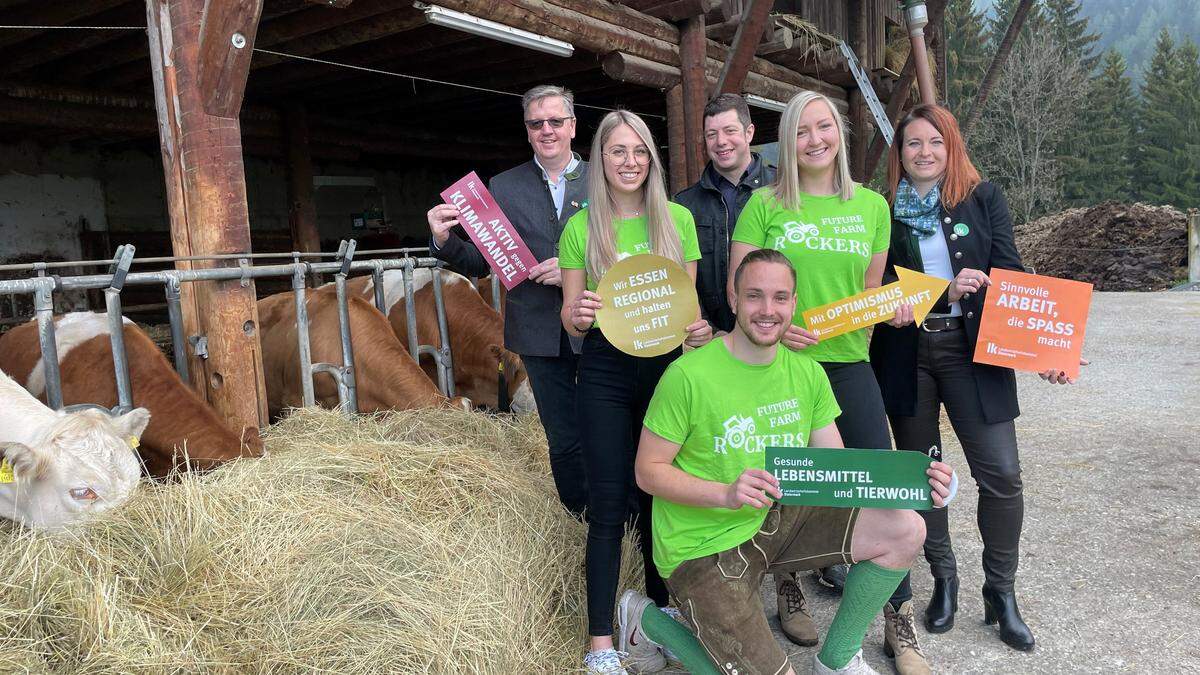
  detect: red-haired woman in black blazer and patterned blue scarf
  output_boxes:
[871,104,1068,651]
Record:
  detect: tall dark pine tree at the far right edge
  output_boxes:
[1135,29,1195,207]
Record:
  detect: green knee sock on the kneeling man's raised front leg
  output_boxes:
[817,560,908,670]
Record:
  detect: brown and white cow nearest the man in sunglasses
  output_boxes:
[348,268,536,413]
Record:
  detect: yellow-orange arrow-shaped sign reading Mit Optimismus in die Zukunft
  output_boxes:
[804,267,950,339]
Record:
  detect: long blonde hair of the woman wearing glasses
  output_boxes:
[586,110,683,280]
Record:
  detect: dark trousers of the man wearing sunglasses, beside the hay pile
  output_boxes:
[521,330,588,515]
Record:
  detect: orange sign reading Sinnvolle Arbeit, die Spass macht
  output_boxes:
[974,269,1092,377]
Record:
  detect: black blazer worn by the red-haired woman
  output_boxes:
[871,183,1025,424]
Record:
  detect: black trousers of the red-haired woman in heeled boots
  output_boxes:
[890,329,1025,591]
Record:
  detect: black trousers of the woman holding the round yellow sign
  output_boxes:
[576,328,680,635]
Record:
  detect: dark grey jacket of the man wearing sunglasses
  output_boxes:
[430,160,588,357]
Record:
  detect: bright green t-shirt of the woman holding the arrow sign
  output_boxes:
[733,186,892,363]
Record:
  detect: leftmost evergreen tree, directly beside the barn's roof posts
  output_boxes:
[944,0,990,117]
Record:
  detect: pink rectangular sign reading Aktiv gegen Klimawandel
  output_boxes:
[442,172,538,291]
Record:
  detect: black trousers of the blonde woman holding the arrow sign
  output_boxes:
[821,362,912,608]
